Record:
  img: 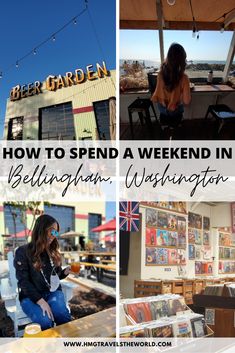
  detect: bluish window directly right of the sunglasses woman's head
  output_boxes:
[44,205,75,234]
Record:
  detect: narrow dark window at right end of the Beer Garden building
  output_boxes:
[93,100,110,140]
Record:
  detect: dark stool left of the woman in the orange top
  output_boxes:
[128,98,157,139]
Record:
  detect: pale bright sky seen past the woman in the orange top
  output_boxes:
[120,30,232,61]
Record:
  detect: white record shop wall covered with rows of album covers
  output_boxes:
[120,202,235,297]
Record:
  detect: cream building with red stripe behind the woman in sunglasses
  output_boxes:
[0,202,106,256]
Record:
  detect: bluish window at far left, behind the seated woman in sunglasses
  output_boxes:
[4,204,25,235]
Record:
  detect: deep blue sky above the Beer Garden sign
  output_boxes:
[0,0,116,138]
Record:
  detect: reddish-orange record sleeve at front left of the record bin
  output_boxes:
[125,302,152,323]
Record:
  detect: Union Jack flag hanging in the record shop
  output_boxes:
[119,201,140,232]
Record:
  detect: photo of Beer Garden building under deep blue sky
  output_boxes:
[0,0,116,140]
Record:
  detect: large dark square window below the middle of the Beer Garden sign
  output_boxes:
[39,102,75,140]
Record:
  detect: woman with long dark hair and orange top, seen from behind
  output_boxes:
[152,43,191,126]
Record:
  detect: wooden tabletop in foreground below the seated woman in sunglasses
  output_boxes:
[40,307,116,337]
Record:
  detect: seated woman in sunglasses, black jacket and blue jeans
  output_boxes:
[14,215,71,330]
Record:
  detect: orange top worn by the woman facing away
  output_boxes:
[152,73,191,111]
